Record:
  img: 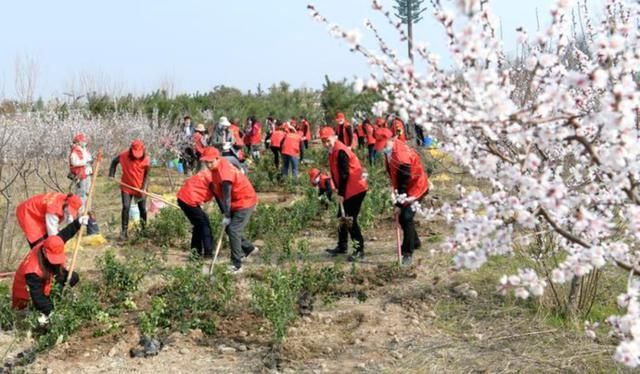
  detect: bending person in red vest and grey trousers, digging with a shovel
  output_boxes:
[203,150,258,274]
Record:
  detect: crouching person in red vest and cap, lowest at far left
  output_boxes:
[11,215,89,325]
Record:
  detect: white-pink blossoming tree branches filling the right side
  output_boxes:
[309,0,640,367]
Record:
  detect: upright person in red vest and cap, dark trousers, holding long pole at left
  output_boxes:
[109,140,151,240]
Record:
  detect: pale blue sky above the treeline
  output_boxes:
[0,0,602,98]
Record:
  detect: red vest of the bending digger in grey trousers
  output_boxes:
[211,159,258,212]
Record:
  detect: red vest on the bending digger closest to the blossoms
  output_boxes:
[385,140,429,199]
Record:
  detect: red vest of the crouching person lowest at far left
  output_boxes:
[11,244,53,309]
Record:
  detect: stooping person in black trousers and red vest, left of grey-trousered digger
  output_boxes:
[177,147,220,257]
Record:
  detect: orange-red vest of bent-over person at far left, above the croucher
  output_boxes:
[16,192,67,243]
